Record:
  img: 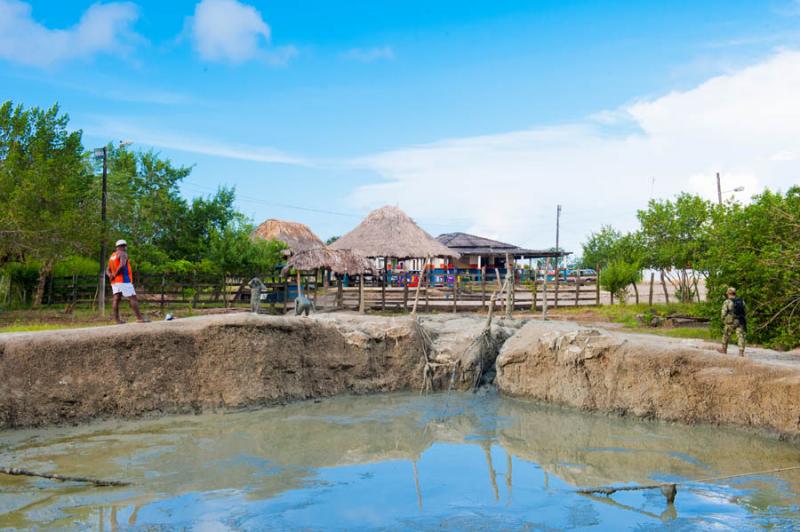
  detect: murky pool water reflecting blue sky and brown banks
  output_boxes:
[0,393,800,529]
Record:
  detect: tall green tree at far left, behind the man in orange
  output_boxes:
[0,102,98,306]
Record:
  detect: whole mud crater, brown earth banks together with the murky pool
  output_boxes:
[0,314,800,529]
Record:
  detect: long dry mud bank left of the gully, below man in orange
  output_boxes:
[0,314,510,429]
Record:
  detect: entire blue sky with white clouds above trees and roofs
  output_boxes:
[0,0,800,249]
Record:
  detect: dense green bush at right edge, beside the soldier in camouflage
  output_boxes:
[702,187,800,348]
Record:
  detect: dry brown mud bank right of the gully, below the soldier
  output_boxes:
[497,321,800,442]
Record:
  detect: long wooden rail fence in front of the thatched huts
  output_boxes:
[44,273,600,314]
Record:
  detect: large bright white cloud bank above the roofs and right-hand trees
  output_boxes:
[350,50,800,251]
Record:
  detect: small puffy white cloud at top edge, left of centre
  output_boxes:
[189,0,297,65]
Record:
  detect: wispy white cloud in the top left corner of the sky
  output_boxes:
[0,0,141,67]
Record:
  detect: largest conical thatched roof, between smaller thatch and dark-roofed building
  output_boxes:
[330,206,460,259]
